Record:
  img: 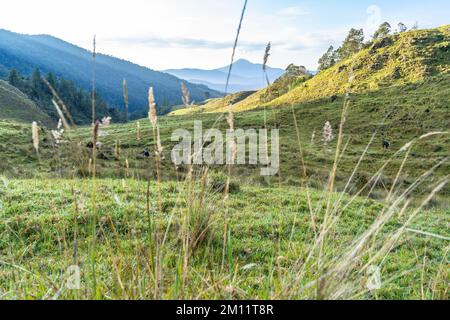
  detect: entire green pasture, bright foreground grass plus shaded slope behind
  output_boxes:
[0,69,450,299]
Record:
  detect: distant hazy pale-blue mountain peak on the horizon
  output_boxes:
[164,59,284,93]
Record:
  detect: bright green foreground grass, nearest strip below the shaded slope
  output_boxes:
[0,179,449,299]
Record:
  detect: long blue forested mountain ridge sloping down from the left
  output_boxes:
[0,29,219,117]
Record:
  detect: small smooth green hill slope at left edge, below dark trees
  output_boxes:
[0,80,52,125]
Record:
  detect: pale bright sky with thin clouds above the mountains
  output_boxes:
[0,0,450,70]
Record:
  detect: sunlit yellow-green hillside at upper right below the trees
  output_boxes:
[175,25,450,112]
